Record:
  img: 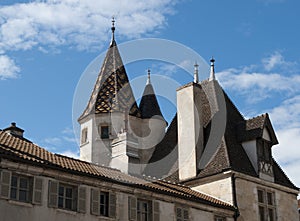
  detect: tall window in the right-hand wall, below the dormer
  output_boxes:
[257,189,276,221]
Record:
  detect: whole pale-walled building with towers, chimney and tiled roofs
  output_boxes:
[0,21,299,221]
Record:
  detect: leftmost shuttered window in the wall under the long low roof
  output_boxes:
[10,175,32,202]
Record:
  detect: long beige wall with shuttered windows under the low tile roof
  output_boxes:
[0,159,234,221]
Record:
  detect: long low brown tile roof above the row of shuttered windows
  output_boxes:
[0,131,235,211]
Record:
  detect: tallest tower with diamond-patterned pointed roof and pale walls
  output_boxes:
[78,18,140,169]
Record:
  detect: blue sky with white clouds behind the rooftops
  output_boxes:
[0,0,300,190]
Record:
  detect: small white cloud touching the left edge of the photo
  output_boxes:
[0,55,20,80]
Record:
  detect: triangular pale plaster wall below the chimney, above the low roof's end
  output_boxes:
[192,177,233,204]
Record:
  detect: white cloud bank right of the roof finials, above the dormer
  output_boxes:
[216,51,300,96]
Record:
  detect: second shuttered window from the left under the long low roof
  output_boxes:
[58,184,76,210]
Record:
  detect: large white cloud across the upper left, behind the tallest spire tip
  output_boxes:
[0,0,174,51]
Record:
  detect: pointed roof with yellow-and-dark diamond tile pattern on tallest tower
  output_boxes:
[79,39,140,120]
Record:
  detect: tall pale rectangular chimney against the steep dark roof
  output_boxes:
[177,82,203,180]
